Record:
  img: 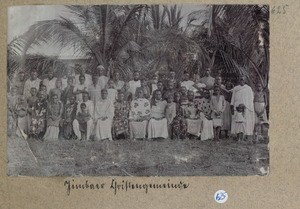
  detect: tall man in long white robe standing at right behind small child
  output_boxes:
[231,76,255,137]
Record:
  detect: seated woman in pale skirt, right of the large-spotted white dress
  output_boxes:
[148,90,168,139]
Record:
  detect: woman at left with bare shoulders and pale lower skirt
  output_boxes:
[43,94,63,141]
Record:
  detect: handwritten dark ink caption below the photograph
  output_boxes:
[63,179,189,196]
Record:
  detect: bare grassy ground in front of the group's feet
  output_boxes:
[8,138,269,176]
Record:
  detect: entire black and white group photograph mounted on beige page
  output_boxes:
[7,4,270,177]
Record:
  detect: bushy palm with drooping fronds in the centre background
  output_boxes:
[143,5,209,78]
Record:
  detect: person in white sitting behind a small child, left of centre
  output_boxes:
[73,92,94,140]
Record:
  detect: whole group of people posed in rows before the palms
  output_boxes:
[8,65,268,141]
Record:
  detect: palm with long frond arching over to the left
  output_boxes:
[17,5,144,80]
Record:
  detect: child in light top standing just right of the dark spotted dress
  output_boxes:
[210,86,225,141]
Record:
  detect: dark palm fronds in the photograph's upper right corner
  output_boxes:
[189,5,269,87]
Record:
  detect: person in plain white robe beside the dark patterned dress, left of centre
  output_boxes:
[95,89,114,141]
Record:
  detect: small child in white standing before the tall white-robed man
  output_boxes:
[234,104,246,141]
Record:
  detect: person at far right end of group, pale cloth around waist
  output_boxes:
[254,83,268,141]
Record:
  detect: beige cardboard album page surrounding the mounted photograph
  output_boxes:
[0,0,300,209]
